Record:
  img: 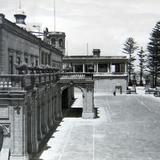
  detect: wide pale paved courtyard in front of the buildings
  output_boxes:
[40,94,160,160]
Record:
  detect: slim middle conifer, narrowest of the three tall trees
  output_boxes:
[137,47,146,86]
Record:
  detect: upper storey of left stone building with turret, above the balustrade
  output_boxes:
[0,13,65,74]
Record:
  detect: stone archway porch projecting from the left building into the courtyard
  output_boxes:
[58,79,96,119]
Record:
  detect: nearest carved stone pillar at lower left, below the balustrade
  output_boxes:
[10,92,29,160]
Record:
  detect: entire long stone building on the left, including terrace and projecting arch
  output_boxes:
[0,12,95,160]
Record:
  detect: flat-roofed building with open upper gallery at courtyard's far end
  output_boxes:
[63,49,128,93]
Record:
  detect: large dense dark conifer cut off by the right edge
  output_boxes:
[147,22,160,87]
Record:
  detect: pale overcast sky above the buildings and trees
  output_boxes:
[0,0,160,56]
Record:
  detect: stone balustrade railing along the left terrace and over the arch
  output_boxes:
[0,72,93,90]
